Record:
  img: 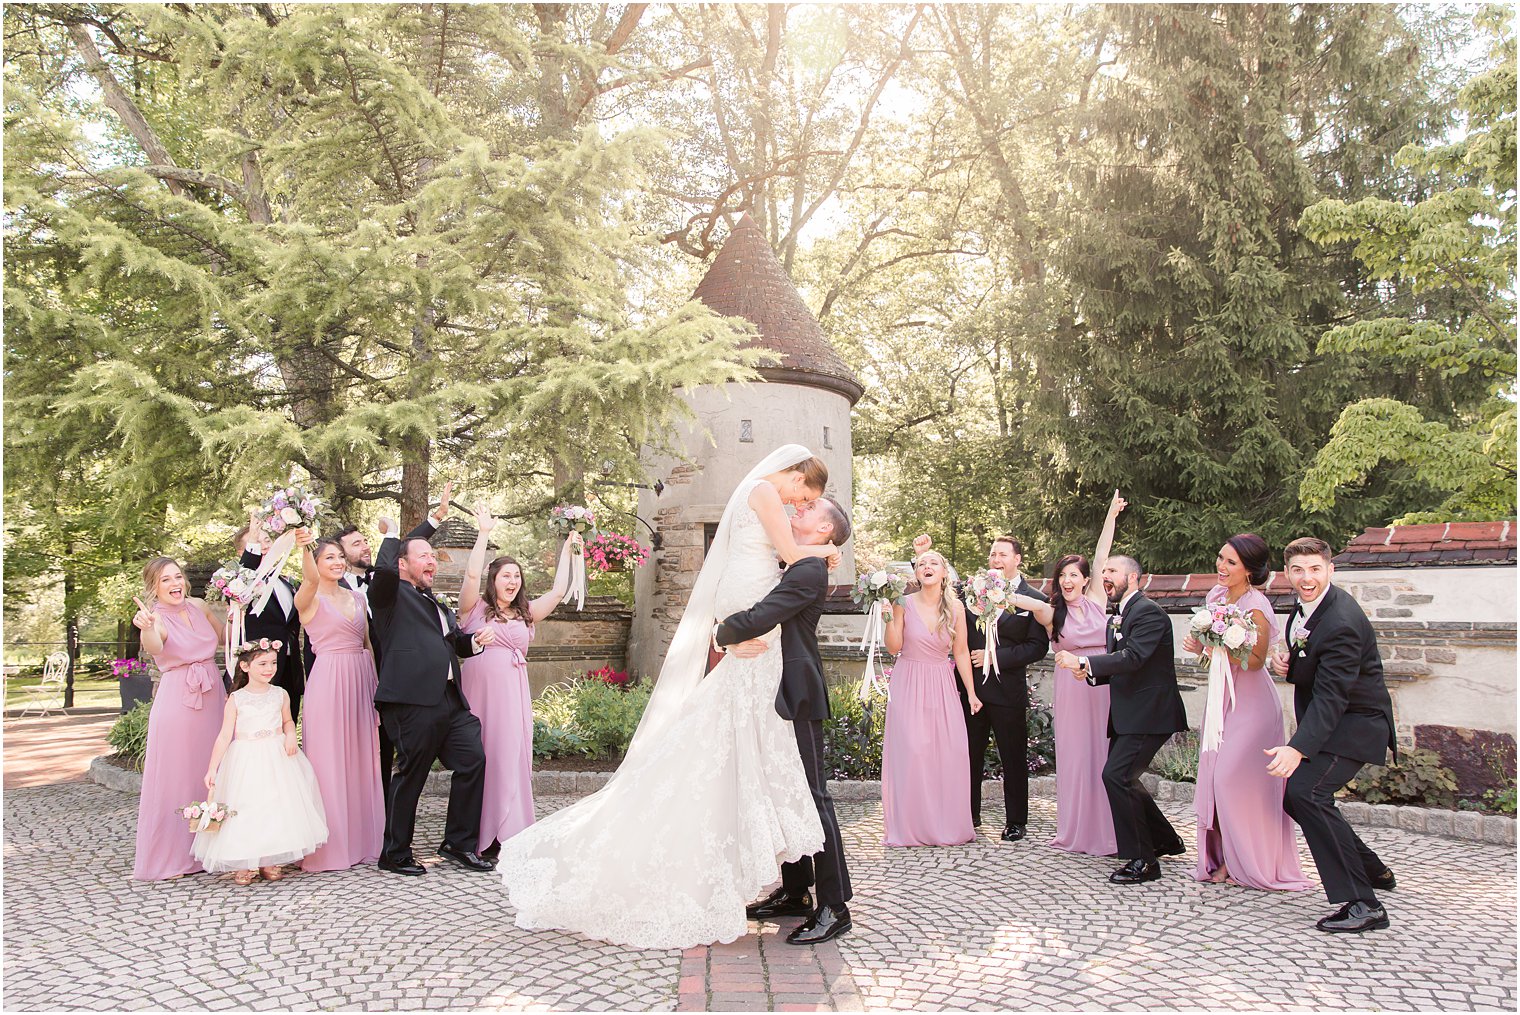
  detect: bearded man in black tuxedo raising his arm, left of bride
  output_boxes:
[369,486,494,875]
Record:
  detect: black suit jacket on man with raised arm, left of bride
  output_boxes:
[369,518,476,705]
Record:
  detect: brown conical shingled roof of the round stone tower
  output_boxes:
[693,213,865,406]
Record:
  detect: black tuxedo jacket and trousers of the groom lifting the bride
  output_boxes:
[713,556,853,906]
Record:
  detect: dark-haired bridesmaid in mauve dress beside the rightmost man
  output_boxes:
[1183,532,1312,892]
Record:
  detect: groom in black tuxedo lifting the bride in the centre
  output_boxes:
[713,497,851,945]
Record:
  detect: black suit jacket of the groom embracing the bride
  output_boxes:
[714,556,828,720]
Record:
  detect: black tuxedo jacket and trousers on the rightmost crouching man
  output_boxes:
[1283,585,1398,904]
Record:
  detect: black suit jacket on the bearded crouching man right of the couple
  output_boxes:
[1087,594,1187,737]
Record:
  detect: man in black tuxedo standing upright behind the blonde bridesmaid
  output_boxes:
[914,535,1050,842]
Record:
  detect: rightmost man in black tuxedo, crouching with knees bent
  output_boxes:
[1266,538,1398,933]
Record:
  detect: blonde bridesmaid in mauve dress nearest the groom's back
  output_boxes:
[882,550,982,846]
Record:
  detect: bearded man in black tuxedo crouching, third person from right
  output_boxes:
[1055,556,1187,884]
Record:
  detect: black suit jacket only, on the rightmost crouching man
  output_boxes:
[1283,585,1398,764]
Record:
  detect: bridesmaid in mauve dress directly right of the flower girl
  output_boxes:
[295,530,385,871]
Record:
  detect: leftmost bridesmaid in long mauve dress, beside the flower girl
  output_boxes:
[132,556,226,881]
